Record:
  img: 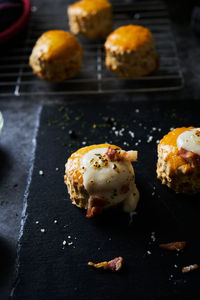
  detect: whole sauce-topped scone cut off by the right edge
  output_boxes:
[157,127,200,194]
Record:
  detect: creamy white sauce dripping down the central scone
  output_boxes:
[82,148,139,212]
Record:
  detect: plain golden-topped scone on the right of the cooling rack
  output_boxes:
[104,25,159,78]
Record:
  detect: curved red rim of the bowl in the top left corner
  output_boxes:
[0,0,31,43]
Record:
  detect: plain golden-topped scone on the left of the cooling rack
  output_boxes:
[29,30,83,82]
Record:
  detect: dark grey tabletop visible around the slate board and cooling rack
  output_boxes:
[0,1,200,300]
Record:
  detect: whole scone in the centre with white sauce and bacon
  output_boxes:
[64,144,139,218]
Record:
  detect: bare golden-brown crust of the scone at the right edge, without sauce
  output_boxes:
[157,127,200,194]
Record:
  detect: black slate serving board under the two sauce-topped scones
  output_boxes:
[11,101,200,300]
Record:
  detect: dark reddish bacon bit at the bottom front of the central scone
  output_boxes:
[86,196,108,218]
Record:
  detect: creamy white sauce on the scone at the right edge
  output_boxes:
[177,128,200,155]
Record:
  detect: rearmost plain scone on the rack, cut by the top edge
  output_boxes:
[68,0,113,39]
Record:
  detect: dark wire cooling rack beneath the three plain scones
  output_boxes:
[0,0,183,96]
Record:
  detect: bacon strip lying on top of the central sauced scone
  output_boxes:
[105,146,138,161]
